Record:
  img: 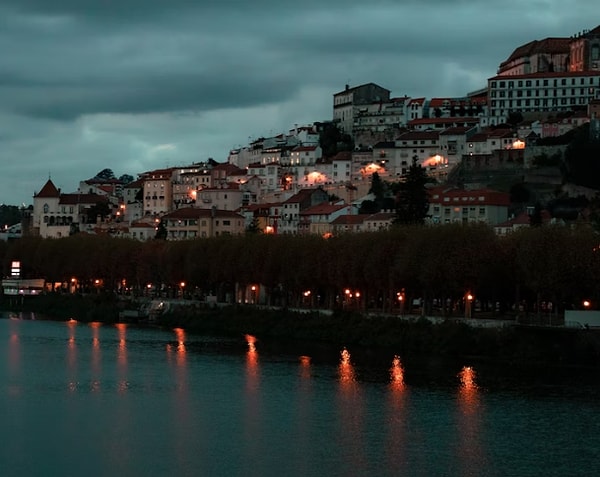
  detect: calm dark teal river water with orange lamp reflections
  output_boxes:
[0,315,600,476]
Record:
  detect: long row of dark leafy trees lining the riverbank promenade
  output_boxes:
[0,225,600,314]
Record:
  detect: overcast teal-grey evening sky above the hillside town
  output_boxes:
[0,0,600,205]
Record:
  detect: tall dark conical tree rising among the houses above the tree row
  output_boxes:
[396,157,429,225]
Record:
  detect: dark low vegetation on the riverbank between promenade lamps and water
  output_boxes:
[0,293,600,368]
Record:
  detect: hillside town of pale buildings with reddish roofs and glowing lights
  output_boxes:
[15,26,600,241]
